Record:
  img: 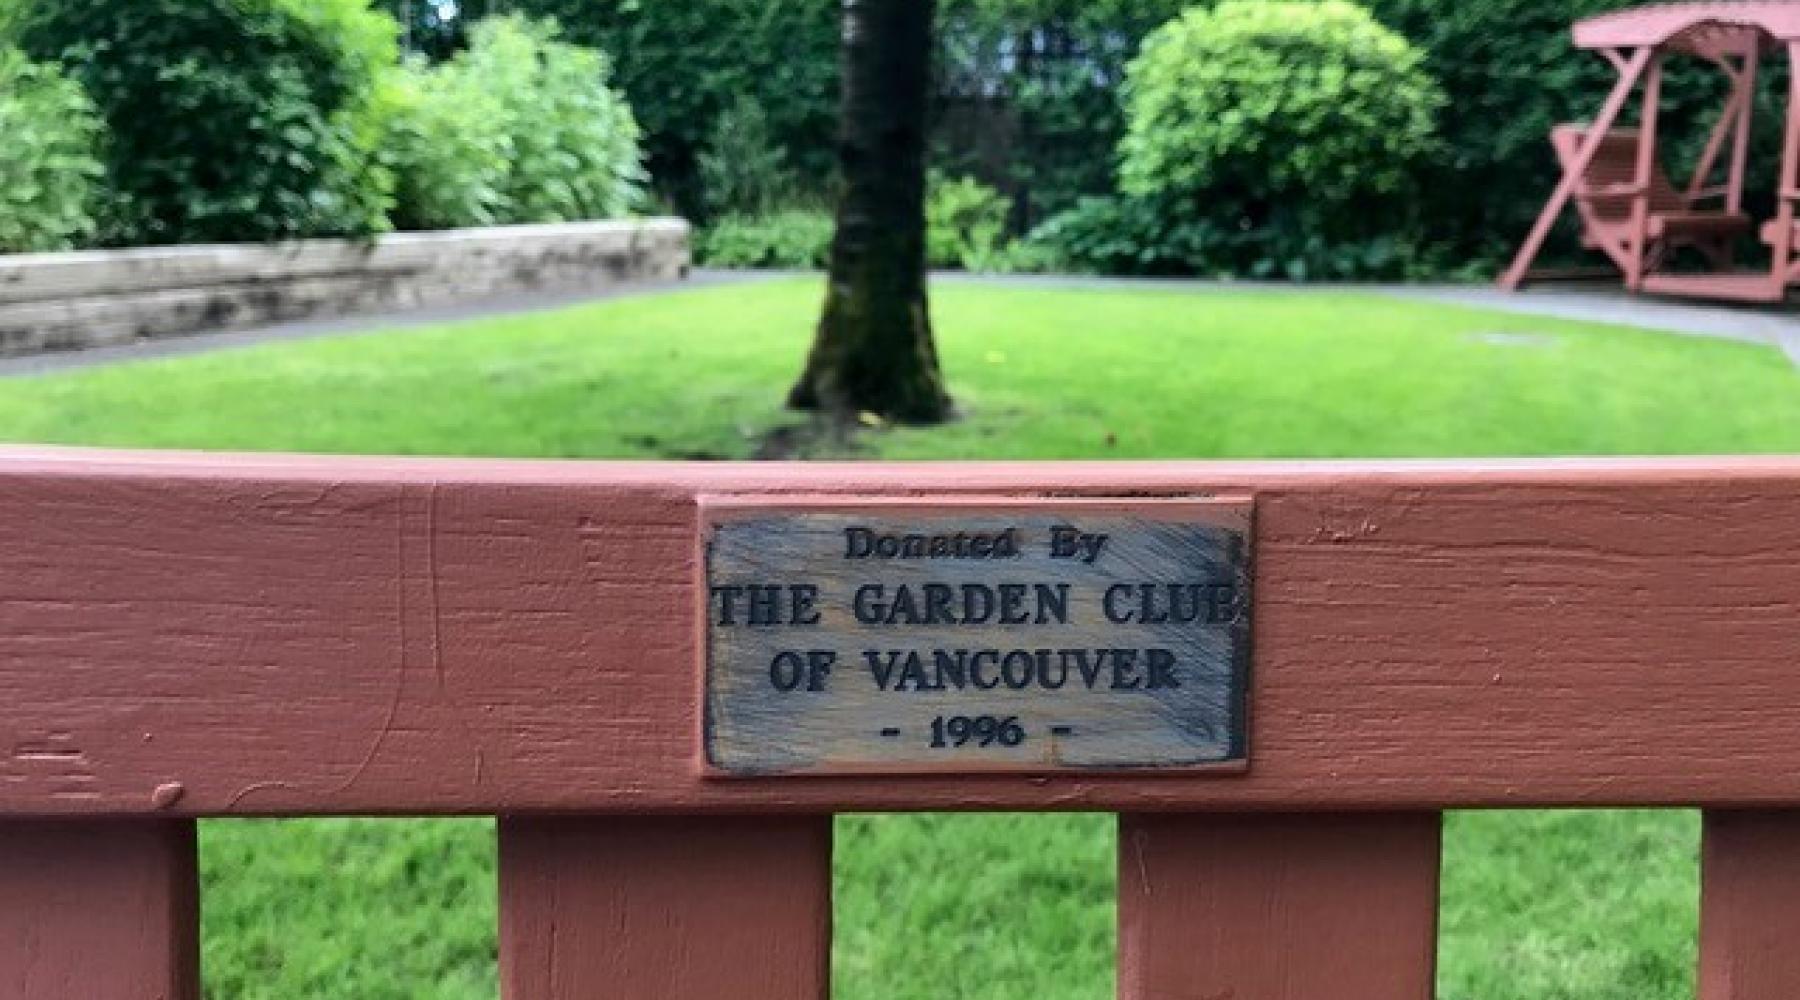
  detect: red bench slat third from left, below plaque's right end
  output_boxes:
[1118,813,1440,1000]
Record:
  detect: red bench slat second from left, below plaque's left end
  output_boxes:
[500,817,832,1000]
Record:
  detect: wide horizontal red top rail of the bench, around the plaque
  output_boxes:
[0,450,1800,817]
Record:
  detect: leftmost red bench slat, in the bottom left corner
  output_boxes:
[0,820,200,1000]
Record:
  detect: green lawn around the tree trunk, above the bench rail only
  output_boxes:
[0,281,1800,459]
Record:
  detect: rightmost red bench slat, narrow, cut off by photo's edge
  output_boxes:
[1699,811,1800,1000]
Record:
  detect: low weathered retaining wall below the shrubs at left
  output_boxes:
[0,219,689,356]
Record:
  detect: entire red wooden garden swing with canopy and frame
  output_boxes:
[1499,0,1800,302]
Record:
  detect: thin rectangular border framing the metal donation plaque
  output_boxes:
[693,493,1256,782]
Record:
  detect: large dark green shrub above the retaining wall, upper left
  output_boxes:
[11,0,396,243]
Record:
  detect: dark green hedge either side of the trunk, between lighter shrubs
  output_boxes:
[507,0,1186,225]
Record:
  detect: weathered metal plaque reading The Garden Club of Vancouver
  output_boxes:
[702,498,1251,775]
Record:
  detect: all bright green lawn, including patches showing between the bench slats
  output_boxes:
[0,281,1800,1000]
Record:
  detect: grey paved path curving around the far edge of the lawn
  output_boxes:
[0,270,1800,376]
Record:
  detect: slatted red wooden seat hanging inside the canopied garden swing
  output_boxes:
[1550,124,1751,270]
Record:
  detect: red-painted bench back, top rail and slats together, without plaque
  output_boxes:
[0,450,1800,1000]
